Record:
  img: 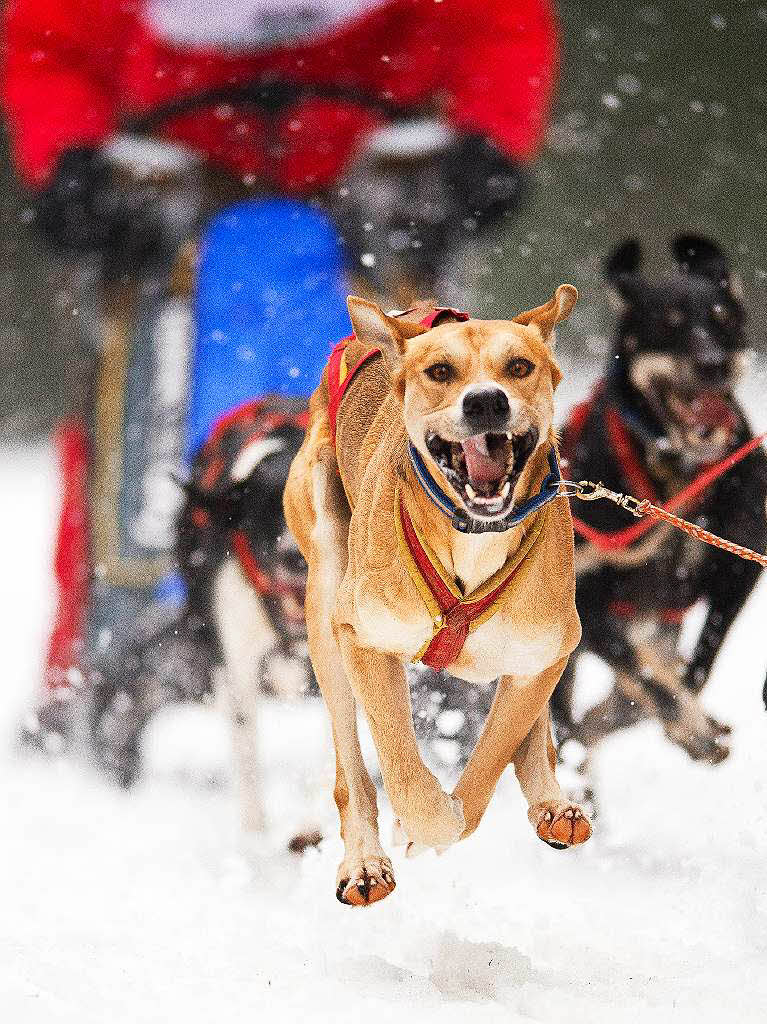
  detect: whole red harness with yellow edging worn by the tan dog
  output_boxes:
[328,308,543,672]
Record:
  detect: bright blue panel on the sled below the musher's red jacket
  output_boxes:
[187,199,351,457]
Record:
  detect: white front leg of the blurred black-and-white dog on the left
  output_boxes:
[213,558,274,833]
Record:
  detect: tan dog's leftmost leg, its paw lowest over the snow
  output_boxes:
[306,462,395,906]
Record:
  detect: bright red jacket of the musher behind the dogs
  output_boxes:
[3,0,557,194]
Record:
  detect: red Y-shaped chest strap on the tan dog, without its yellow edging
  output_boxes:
[399,500,516,672]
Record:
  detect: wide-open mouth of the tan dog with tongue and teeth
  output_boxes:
[426,427,539,518]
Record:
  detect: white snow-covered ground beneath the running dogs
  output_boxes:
[0,362,767,1024]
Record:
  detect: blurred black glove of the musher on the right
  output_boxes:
[440,135,526,230]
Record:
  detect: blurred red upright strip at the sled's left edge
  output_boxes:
[43,420,89,693]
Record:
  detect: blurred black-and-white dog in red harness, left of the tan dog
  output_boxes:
[178,396,313,831]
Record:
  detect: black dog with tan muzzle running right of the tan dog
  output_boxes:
[552,236,767,787]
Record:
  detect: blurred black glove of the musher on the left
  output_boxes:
[36,145,163,272]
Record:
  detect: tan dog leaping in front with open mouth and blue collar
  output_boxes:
[285,285,591,905]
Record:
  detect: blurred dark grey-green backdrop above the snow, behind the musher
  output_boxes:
[0,0,767,440]
